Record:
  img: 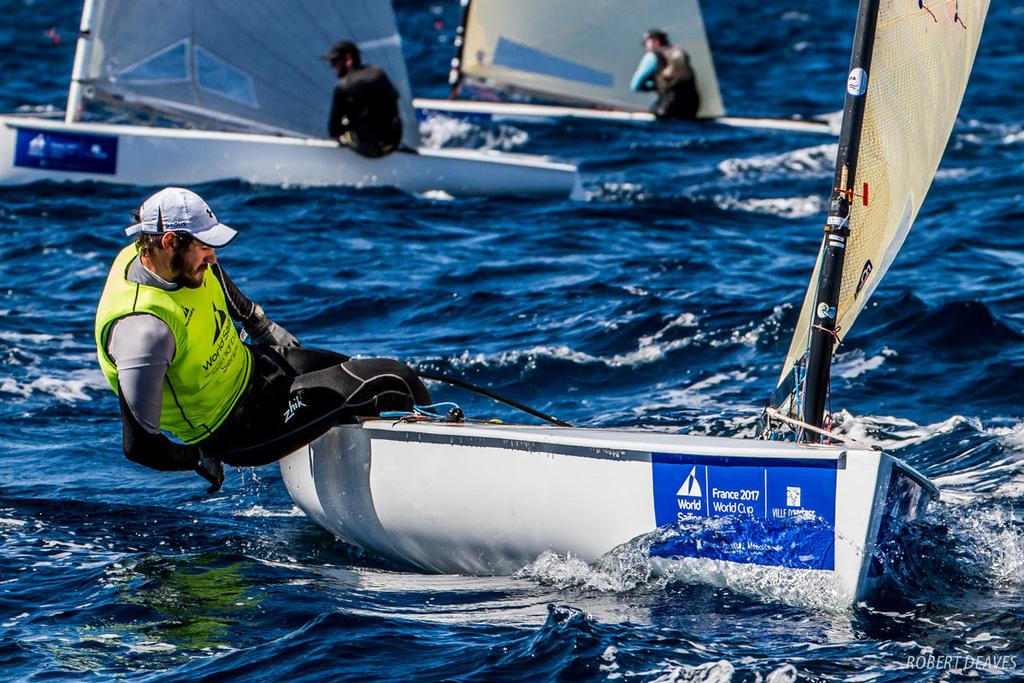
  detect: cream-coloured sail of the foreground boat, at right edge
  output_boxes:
[772,0,988,414]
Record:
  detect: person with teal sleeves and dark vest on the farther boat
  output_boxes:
[630,29,700,119]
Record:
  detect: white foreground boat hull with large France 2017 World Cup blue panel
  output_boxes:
[281,420,935,602]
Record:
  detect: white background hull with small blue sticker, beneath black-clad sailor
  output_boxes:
[0,116,580,197]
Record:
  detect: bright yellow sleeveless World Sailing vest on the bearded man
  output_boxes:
[95,245,252,443]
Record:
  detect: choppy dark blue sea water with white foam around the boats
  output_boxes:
[0,0,1024,682]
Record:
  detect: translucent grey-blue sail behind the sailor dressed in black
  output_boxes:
[75,0,418,145]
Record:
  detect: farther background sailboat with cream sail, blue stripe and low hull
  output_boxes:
[414,0,830,133]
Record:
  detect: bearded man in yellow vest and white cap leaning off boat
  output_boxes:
[95,187,430,493]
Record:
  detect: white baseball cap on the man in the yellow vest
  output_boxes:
[125,187,239,249]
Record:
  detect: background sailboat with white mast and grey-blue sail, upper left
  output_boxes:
[0,0,578,196]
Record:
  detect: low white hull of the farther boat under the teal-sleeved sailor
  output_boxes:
[413,98,839,135]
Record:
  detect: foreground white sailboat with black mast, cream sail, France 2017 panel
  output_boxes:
[282,0,988,604]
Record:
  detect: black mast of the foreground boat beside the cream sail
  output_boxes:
[804,0,879,441]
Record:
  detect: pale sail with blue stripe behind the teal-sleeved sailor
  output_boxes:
[452,0,725,118]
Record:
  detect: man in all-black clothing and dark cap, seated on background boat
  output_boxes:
[323,40,401,157]
